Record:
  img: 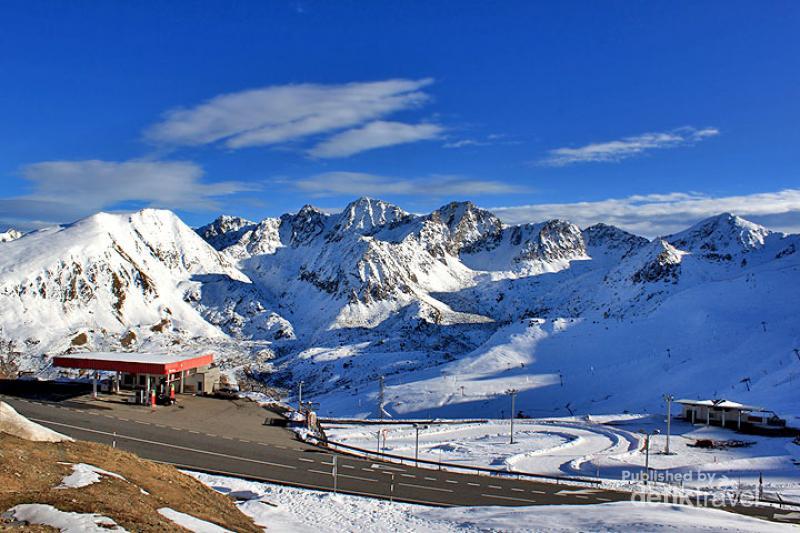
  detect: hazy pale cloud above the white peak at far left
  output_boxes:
[0,160,256,225]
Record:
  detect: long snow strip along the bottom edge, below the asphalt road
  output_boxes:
[187,472,796,533]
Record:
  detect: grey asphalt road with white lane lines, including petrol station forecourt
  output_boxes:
[0,396,798,522]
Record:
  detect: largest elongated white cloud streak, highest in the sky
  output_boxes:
[145,78,433,152]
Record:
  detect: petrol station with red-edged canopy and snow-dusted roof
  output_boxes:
[53,352,220,394]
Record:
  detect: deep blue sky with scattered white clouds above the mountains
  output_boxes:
[0,1,800,236]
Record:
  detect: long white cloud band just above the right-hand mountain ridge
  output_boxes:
[490,189,800,237]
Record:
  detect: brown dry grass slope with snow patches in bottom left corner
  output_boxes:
[0,434,261,532]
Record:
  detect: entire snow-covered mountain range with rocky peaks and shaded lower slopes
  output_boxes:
[0,198,800,416]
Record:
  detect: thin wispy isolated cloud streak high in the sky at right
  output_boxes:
[539,127,719,167]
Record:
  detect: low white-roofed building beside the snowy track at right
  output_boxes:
[677,399,786,430]
